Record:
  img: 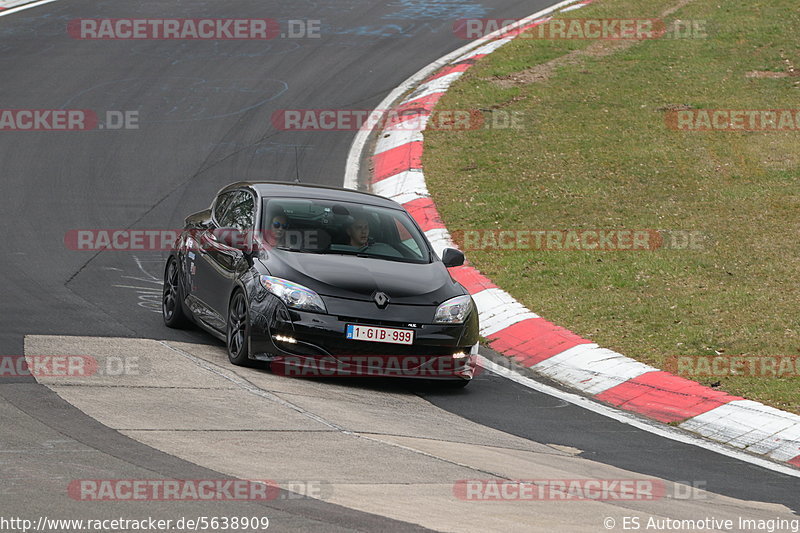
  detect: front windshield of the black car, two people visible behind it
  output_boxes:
[262,198,431,263]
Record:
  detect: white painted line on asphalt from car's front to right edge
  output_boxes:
[478,355,800,478]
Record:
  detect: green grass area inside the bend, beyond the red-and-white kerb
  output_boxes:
[423,0,800,413]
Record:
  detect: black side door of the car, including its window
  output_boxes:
[194,190,256,331]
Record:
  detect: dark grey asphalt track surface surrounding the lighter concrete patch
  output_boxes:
[0,0,800,531]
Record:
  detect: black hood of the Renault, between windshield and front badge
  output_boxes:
[261,250,466,305]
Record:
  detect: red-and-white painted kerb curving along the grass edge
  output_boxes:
[344,0,800,468]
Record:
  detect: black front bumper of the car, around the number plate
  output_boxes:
[250,295,479,379]
